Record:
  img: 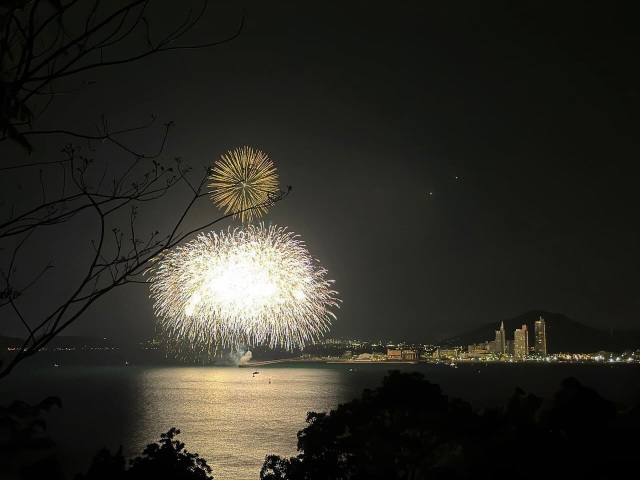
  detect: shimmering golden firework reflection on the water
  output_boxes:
[125,368,346,479]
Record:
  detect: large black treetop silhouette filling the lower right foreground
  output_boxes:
[260,371,640,480]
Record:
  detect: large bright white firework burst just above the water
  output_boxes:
[151,224,338,350]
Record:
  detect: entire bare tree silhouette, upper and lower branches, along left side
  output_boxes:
[0,0,284,378]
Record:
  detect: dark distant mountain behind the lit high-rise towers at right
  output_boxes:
[440,310,640,353]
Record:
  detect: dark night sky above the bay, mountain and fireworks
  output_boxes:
[0,1,640,341]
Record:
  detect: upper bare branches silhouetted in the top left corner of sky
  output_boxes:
[0,0,244,152]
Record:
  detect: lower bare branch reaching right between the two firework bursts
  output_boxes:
[0,141,291,378]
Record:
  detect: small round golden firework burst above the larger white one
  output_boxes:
[209,147,278,222]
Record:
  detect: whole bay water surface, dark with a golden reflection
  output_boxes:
[0,364,640,480]
